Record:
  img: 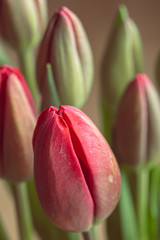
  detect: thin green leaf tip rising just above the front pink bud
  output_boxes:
[46,63,61,108]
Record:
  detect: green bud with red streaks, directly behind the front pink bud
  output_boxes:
[37,7,93,108]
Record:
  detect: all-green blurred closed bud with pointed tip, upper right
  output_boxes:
[101,5,143,142]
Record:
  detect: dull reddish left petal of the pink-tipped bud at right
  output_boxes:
[113,75,147,165]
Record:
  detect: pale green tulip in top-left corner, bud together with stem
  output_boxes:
[0,0,48,107]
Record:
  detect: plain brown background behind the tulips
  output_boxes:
[0,0,160,240]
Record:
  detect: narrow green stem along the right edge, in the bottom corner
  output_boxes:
[149,167,160,240]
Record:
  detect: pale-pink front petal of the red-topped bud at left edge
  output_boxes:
[3,74,35,181]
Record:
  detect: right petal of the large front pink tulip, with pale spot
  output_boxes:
[59,106,120,222]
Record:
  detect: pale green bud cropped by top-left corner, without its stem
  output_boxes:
[0,0,47,50]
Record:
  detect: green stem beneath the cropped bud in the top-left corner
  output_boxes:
[18,49,40,108]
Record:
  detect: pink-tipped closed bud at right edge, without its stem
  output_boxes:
[113,74,160,165]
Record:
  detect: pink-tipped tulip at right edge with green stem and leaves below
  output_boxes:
[109,74,160,240]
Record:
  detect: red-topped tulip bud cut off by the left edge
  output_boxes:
[0,65,36,181]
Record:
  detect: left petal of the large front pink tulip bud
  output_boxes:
[34,108,93,232]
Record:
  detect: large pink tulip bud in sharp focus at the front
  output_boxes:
[33,106,121,232]
